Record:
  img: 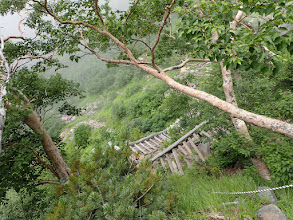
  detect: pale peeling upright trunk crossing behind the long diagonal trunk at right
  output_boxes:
[220,62,271,180]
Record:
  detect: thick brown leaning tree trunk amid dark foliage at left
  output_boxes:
[24,113,70,183]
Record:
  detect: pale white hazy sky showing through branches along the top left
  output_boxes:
[0,0,129,38]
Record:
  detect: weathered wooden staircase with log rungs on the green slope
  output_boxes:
[129,119,213,174]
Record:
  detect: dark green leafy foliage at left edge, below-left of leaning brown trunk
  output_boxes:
[0,109,44,198]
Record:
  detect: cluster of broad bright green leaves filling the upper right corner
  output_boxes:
[177,1,293,73]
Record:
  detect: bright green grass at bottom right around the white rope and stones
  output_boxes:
[169,168,293,219]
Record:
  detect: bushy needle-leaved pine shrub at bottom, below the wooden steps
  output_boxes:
[47,148,175,219]
